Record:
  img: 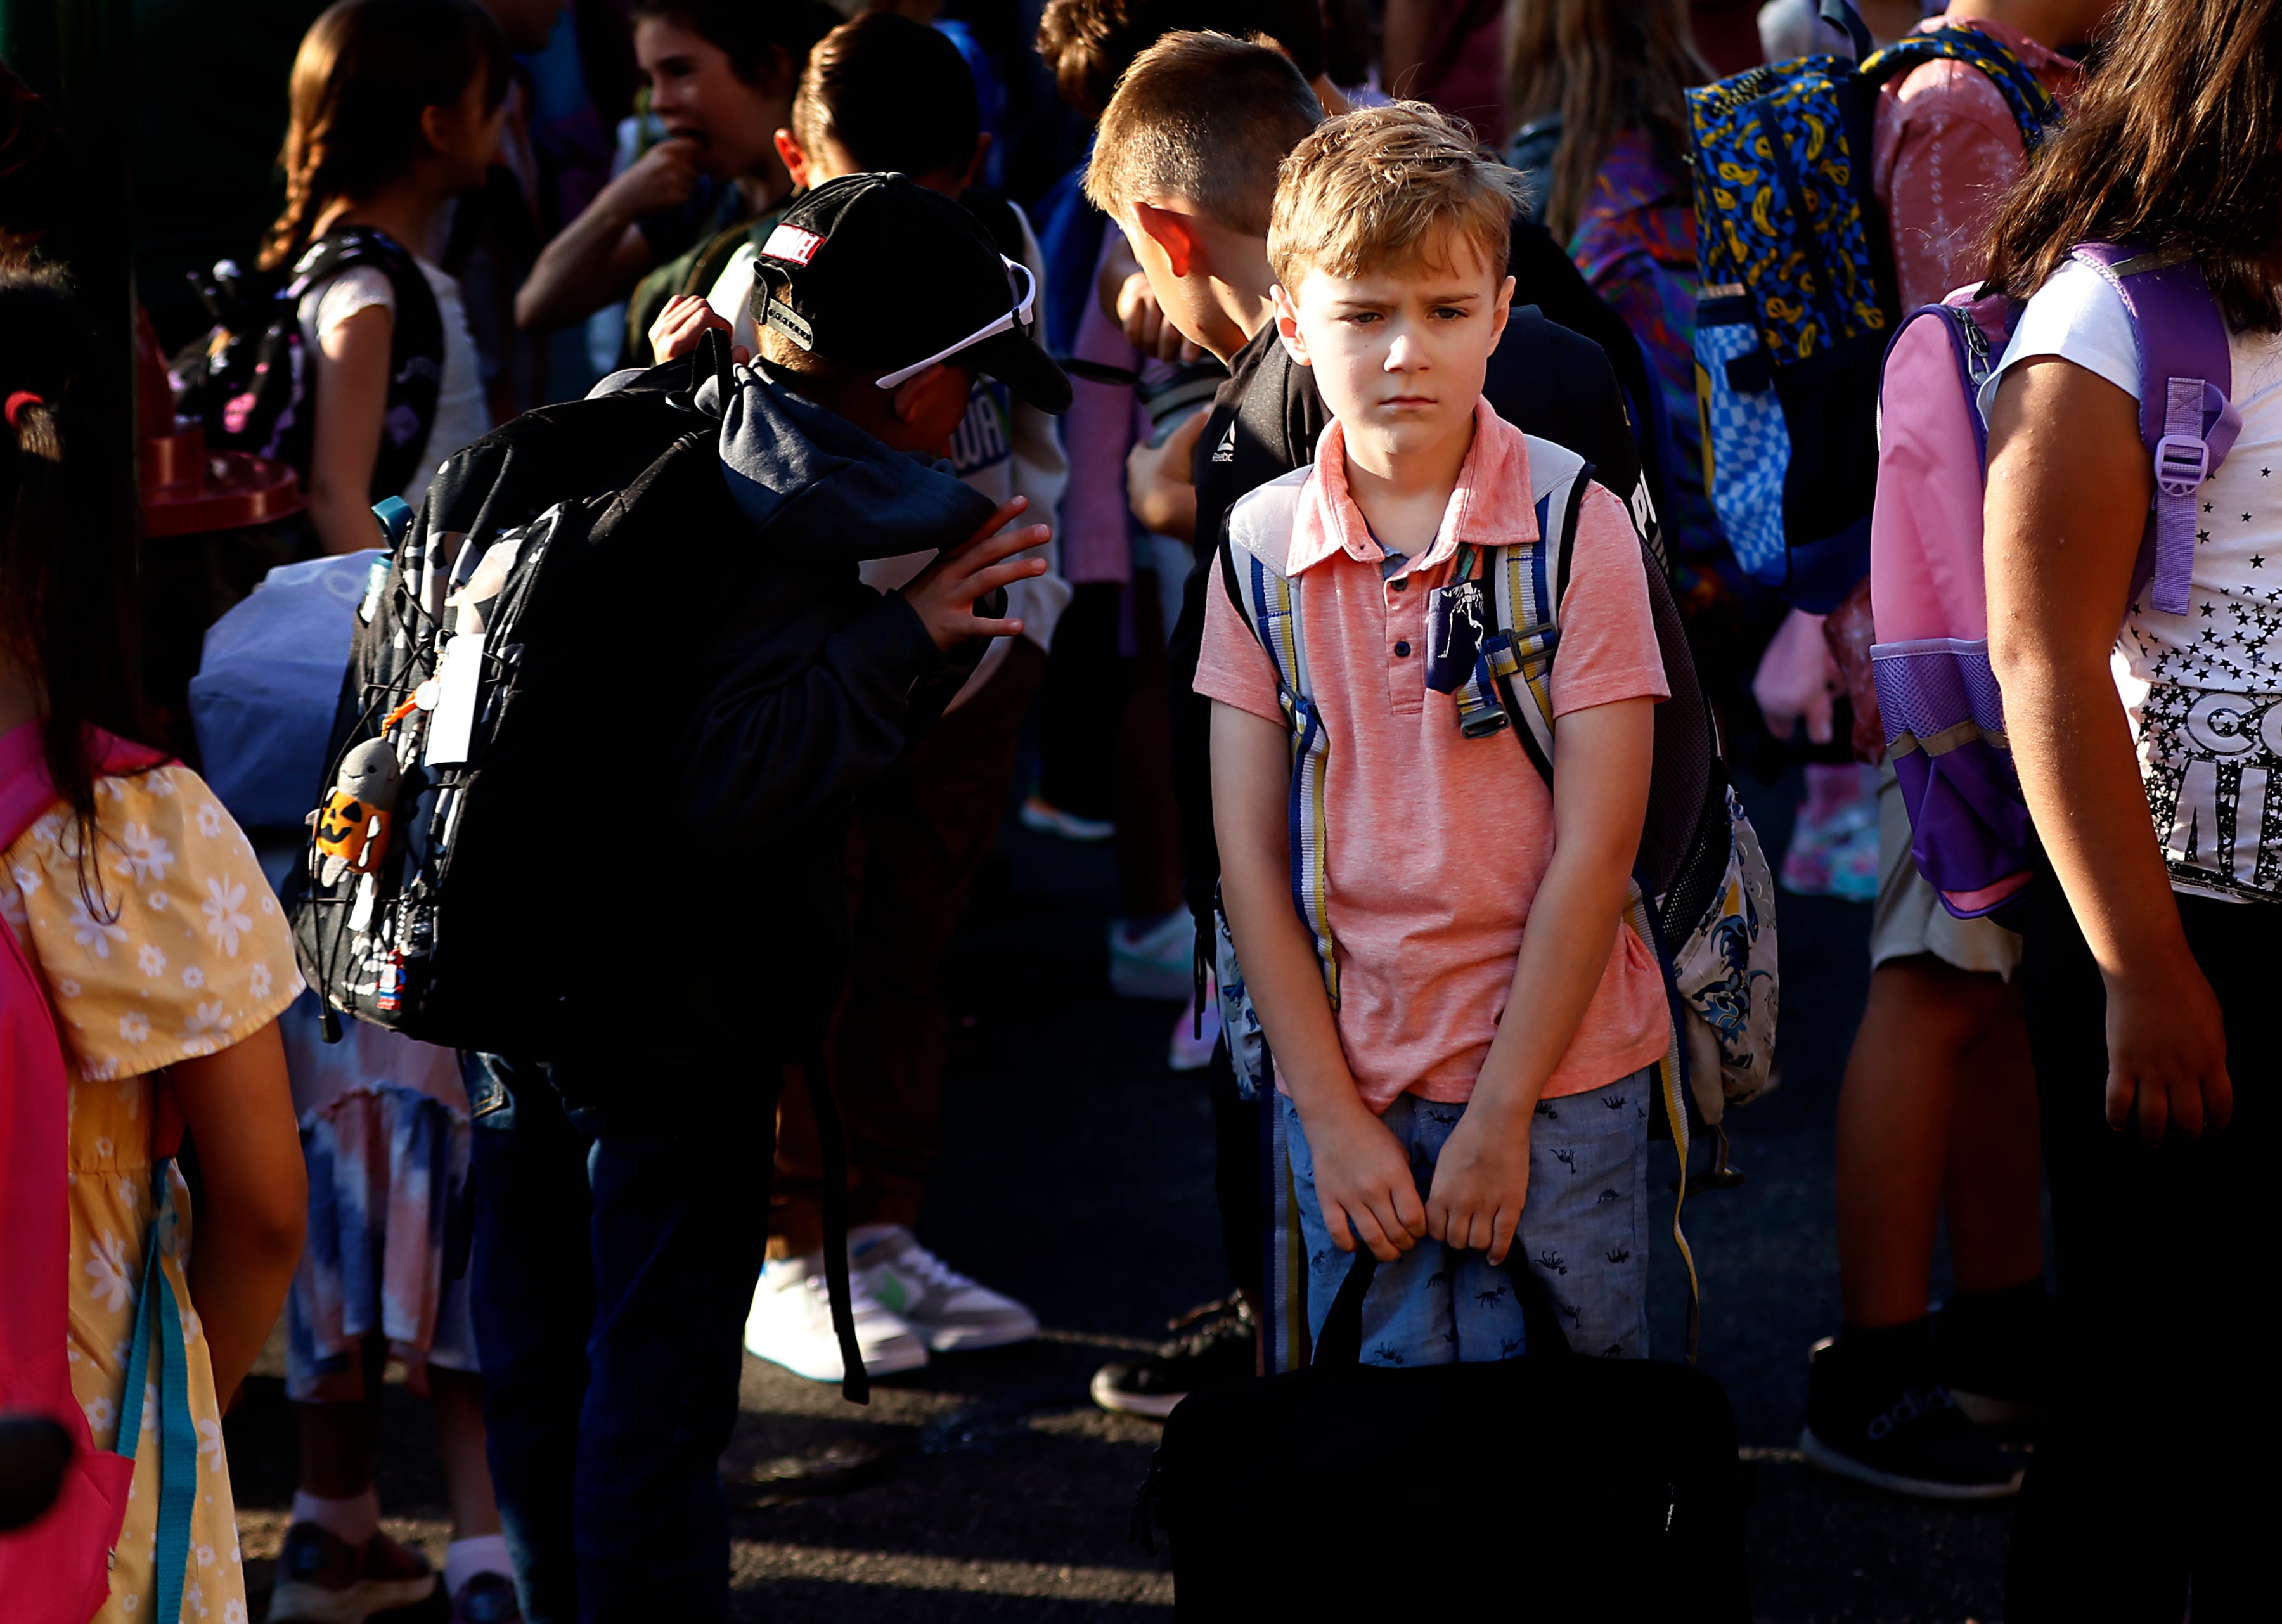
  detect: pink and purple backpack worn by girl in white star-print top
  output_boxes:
[1869,242,2241,924]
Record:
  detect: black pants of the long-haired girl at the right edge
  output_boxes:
[2006,873,2282,1624]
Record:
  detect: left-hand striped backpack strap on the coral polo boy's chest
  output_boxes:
[1221,468,1339,1010]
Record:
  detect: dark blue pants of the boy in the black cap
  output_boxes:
[461,1054,776,1624]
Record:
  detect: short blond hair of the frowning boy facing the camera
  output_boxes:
[1269,103,1520,294]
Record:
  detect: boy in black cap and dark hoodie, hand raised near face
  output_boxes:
[470,176,1070,1624]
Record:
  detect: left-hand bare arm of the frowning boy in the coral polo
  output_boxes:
[1212,700,1426,1263]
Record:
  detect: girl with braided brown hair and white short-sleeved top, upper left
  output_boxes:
[260,0,509,552]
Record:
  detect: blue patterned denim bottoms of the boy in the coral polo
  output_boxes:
[1275,1070,1657,1366]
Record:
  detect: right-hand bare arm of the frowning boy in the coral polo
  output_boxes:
[1433,698,1657,1263]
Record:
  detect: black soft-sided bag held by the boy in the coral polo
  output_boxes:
[1134,1252,1750,1624]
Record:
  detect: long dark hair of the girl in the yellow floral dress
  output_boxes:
[0,267,139,898]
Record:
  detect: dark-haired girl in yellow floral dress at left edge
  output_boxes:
[0,271,306,1624]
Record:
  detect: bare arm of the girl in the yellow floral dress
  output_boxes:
[174,1022,308,1410]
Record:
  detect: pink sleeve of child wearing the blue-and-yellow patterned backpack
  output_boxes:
[1871,61,2022,310]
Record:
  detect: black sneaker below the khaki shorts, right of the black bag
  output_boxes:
[1798,1337,2020,1501]
